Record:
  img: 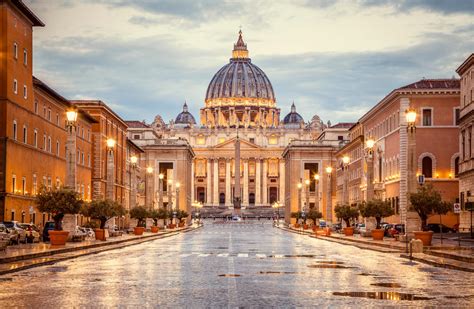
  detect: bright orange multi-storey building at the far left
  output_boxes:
[0,1,95,224]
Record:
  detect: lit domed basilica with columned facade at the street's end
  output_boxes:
[128,32,334,214]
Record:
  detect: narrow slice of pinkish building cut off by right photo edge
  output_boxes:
[456,54,474,231]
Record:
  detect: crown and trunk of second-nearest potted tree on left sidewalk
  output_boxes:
[81,199,126,229]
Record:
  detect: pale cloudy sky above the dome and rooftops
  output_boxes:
[24,0,474,123]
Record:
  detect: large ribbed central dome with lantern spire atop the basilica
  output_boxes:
[205,31,275,107]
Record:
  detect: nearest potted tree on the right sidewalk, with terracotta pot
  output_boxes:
[410,184,451,246]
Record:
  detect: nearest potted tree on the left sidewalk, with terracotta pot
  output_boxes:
[36,186,83,246]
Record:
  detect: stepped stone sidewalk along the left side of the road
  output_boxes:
[0,226,201,275]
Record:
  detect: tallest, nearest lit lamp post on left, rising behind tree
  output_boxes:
[66,109,77,190]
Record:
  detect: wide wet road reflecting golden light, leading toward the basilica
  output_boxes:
[0,221,474,308]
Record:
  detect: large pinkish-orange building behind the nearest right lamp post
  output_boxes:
[337,79,460,226]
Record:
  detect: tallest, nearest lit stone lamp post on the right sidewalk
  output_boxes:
[400,108,419,242]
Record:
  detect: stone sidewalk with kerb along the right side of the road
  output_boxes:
[279,226,474,272]
